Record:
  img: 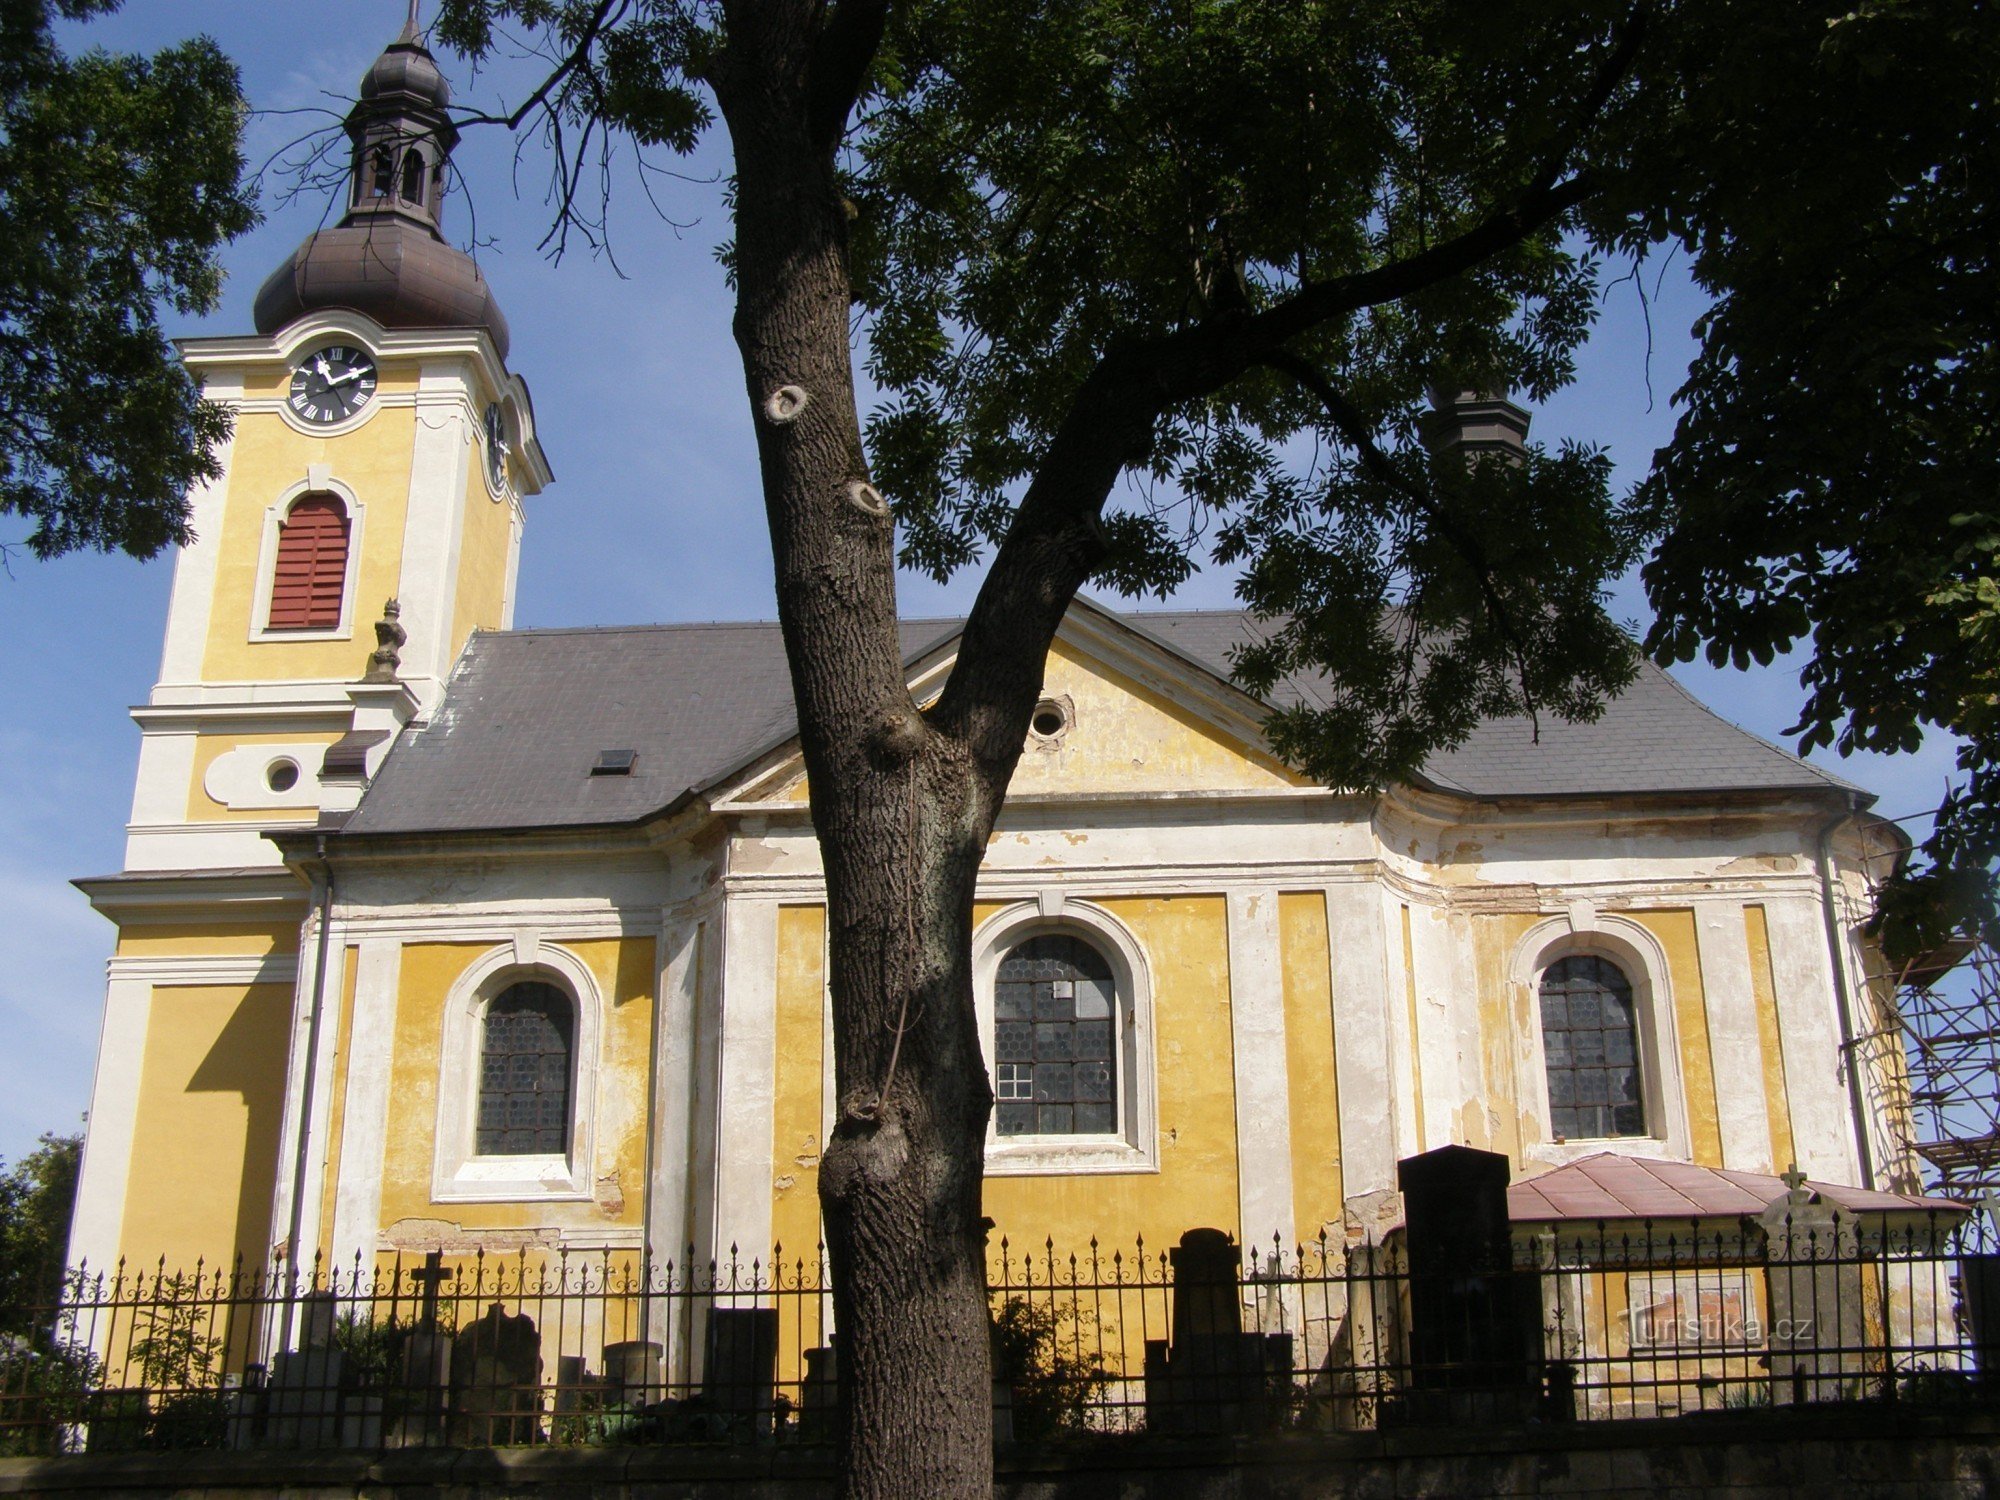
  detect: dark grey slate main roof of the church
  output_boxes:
[344,606,1850,834]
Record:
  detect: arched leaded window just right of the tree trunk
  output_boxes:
[994,934,1118,1136]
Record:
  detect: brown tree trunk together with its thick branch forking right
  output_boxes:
[710,0,1616,1500]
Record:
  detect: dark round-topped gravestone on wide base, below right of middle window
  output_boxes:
[1146,1228,1292,1432]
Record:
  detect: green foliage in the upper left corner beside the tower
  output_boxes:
[0,0,256,558]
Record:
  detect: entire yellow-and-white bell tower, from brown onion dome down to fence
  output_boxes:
[74,6,552,1266]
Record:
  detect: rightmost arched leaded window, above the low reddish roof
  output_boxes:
[1542,954,1646,1140]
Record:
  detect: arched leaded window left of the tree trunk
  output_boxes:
[476,980,576,1156]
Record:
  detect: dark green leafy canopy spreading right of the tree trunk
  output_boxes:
[438,0,2000,942]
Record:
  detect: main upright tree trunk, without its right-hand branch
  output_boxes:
[716,17,1008,1500]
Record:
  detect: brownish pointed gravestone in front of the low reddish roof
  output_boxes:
[1758,1166,1876,1406]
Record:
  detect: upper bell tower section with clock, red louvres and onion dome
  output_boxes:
[126,18,550,870]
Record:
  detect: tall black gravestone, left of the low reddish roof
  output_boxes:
[1396,1146,1542,1422]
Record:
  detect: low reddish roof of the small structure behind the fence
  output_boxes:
[1506,1152,1968,1224]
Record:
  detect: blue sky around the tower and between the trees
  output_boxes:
[0,0,1950,1160]
